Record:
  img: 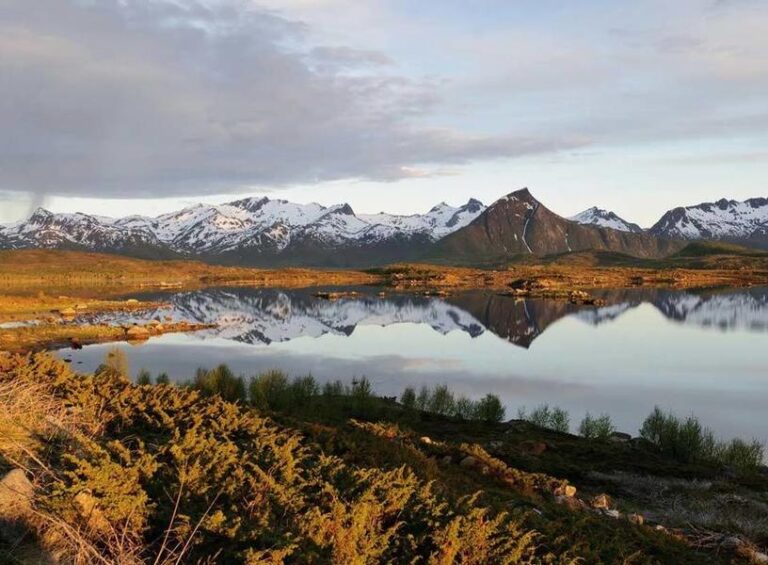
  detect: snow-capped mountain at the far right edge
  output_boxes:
[649,198,768,247]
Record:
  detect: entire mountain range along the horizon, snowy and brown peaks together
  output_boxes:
[0,189,768,266]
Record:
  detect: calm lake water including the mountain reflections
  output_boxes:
[58,288,768,442]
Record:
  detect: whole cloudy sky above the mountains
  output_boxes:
[0,0,768,226]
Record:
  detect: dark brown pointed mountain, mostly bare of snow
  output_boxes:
[432,189,683,262]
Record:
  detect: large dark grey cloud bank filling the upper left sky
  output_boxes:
[0,0,585,197]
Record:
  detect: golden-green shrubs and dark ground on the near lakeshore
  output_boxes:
[0,353,768,564]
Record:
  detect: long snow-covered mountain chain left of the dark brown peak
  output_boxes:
[0,198,485,263]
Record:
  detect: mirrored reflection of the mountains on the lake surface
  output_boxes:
[84,288,768,349]
